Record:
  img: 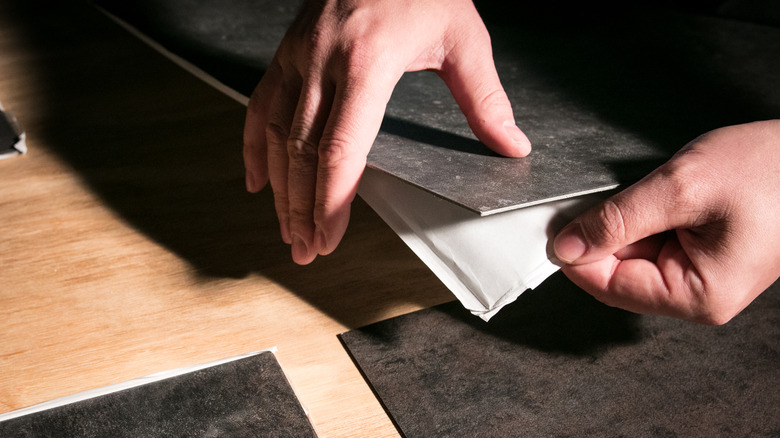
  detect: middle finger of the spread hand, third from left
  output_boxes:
[287,77,334,264]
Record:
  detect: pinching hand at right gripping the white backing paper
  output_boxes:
[554,120,780,324]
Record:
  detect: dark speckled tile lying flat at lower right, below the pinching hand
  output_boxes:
[341,274,780,438]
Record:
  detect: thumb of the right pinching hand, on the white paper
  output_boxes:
[553,167,707,265]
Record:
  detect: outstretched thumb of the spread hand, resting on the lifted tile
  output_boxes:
[439,18,531,157]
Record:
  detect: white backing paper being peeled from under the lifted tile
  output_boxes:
[358,168,608,321]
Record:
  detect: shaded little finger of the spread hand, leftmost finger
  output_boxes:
[244,62,281,193]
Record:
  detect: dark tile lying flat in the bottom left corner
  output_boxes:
[0,352,316,438]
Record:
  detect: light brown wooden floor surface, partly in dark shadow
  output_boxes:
[0,0,452,437]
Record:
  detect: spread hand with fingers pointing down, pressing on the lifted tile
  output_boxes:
[244,0,531,264]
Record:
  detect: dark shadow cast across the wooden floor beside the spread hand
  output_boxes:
[8,2,451,327]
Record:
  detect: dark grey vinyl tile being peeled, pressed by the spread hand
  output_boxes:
[97,0,780,214]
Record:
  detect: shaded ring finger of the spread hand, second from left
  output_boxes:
[265,71,300,244]
